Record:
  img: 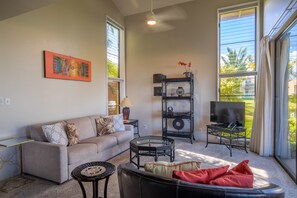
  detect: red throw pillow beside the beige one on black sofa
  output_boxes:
[172,165,229,184]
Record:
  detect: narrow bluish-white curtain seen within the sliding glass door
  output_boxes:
[276,34,290,158]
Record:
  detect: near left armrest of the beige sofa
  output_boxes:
[22,141,68,183]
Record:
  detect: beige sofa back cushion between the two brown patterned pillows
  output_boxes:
[65,117,96,140]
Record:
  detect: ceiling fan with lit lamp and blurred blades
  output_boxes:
[146,0,187,32]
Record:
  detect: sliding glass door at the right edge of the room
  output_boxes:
[275,22,297,181]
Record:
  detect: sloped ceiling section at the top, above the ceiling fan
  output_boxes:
[112,0,193,16]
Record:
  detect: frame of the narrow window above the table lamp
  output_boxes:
[105,16,126,114]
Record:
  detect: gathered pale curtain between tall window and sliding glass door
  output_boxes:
[250,36,273,156]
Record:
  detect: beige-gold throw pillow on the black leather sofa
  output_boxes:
[144,161,201,177]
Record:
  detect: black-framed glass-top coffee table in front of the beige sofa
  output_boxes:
[130,136,175,169]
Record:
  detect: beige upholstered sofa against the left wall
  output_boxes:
[22,115,134,184]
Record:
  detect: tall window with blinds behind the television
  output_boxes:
[218,5,257,138]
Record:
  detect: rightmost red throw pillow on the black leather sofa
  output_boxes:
[209,160,254,188]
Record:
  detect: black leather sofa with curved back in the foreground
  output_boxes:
[117,163,285,198]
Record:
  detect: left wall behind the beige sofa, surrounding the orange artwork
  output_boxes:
[0,0,124,180]
